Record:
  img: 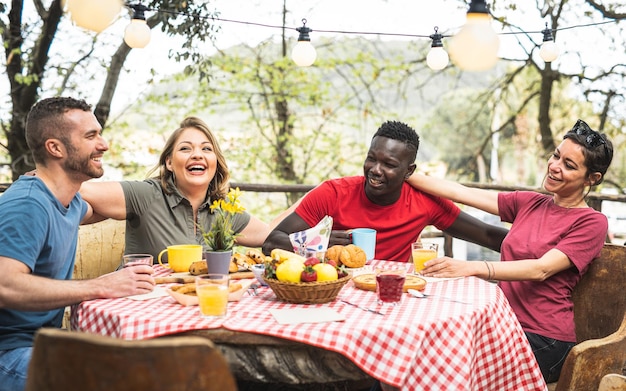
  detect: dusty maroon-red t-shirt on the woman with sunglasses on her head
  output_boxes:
[498,191,608,342]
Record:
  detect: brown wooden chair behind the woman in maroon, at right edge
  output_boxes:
[548,244,626,391]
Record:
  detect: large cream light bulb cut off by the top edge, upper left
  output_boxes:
[66,0,122,33]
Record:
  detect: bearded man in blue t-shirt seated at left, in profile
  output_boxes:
[0,97,154,391]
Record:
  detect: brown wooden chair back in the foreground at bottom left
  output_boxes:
[26,328,237,391]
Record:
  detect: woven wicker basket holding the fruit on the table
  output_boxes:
[263,275,352,304]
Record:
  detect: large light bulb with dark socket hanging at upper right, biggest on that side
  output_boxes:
[448,0,500,71]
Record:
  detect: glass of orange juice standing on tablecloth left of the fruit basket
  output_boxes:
[196,274,228,319]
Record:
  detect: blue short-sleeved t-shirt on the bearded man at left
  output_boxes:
[0,176,87,350]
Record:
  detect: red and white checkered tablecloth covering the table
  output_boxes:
[71,266,546,391]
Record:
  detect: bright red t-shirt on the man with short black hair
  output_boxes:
[295,176,460,262]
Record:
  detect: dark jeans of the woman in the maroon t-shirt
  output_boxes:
[526,332,575,383]
